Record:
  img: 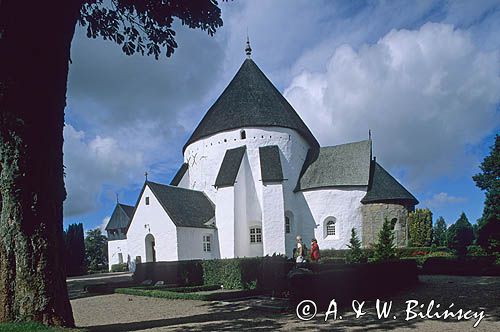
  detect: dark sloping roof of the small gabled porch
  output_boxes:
[146,181,215,228]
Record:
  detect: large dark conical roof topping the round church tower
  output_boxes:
[183,59,319,151]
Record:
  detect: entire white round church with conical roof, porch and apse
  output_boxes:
[106,46,418,270]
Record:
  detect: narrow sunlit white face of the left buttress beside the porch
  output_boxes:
[215,187,235,258]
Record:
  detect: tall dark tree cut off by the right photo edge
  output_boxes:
[472,135,500,253]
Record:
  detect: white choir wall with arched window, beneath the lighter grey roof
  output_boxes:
[303,187,366,249]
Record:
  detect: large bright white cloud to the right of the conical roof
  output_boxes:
[285,23,500,186]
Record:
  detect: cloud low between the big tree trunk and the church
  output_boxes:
[64,124,145,217]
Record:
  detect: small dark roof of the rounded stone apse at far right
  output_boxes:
[361,161,418,205]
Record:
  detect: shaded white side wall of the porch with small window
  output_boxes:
[177,227,220,260]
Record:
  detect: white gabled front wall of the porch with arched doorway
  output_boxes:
[127,186,178,268]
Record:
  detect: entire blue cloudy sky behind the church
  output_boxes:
[64,1,500,230]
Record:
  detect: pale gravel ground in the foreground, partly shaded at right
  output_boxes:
[71,276,500,332]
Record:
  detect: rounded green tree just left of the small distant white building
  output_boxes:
[85,228,108,271]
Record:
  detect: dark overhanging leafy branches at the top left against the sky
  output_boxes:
[78,0,222,59]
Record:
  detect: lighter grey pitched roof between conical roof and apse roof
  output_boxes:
[295,140,371,191]
